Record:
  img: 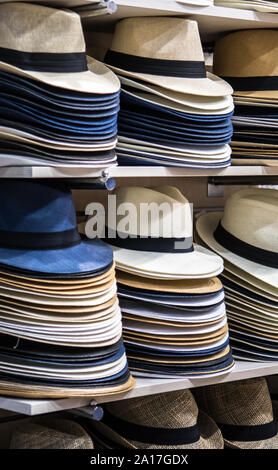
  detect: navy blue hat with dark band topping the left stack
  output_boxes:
[0,180,113,275]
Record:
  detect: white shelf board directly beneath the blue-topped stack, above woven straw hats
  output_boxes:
[0,361,278,416]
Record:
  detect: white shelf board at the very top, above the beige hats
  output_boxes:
[82,0,278,40]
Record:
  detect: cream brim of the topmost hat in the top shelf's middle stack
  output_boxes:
[107,64,233,97]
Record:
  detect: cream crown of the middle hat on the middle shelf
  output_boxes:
[107,186,193,238]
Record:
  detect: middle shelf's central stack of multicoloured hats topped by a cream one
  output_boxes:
[104,186,234,378]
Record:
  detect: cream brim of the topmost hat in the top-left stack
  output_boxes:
[0,56,120,94]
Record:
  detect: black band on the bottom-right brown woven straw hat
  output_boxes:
[217,420,277,442]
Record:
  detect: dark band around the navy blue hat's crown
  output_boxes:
[0,228,81,250]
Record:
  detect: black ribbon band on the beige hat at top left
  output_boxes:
[0,47,88,73]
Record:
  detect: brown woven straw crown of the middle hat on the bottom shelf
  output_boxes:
[106,390,198,429]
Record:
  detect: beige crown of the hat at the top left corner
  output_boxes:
[0,3,85,53]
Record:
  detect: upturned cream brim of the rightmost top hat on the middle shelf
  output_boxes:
[196,212,278,288]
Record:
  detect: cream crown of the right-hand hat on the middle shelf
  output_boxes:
[221,188,278,253]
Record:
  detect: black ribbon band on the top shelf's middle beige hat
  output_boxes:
[104,50,207,78]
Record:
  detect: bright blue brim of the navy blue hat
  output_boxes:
[0,240,113,275]
